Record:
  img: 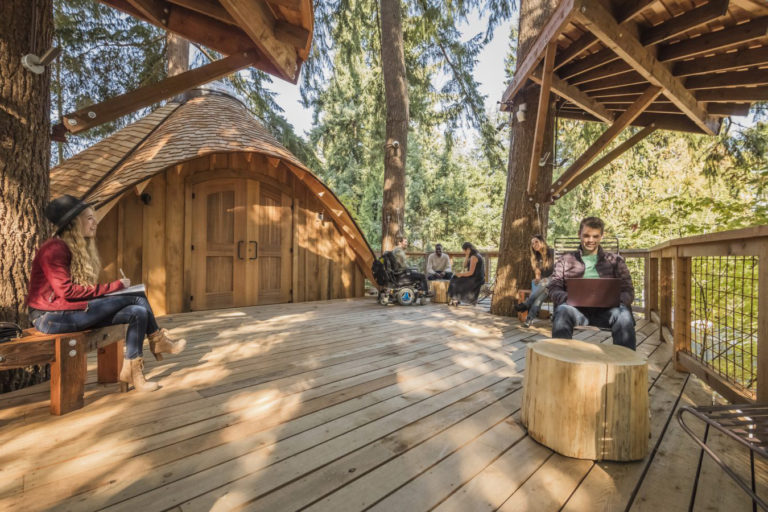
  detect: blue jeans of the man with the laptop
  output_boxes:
[552,304,637,350]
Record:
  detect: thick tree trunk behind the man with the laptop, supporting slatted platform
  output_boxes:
[491,0,558,316]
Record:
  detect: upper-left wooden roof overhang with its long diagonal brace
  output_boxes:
[58,0,314,133]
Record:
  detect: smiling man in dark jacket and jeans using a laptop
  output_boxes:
[548,217,635,350]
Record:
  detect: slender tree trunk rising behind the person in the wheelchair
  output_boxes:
[381,0,408,252]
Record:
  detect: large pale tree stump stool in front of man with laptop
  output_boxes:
[522,339,650,461]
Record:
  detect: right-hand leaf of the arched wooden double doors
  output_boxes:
[256,183,293,304]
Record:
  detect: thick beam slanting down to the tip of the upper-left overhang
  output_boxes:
[220,0,298,83]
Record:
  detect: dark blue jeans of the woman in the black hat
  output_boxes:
[34,295,158,359]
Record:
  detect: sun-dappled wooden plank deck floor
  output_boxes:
[0,298,768,512]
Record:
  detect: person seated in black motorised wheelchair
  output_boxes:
[372,237,431,306]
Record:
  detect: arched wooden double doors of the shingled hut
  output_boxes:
[190,178,293,311]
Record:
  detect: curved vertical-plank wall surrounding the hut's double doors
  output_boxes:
[97,153,365,315]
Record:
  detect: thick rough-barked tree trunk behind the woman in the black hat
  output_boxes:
[0,0,53,392]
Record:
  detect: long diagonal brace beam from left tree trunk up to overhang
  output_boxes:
[64,52,253,133]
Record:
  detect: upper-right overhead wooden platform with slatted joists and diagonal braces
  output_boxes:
[501,0,768,201]
